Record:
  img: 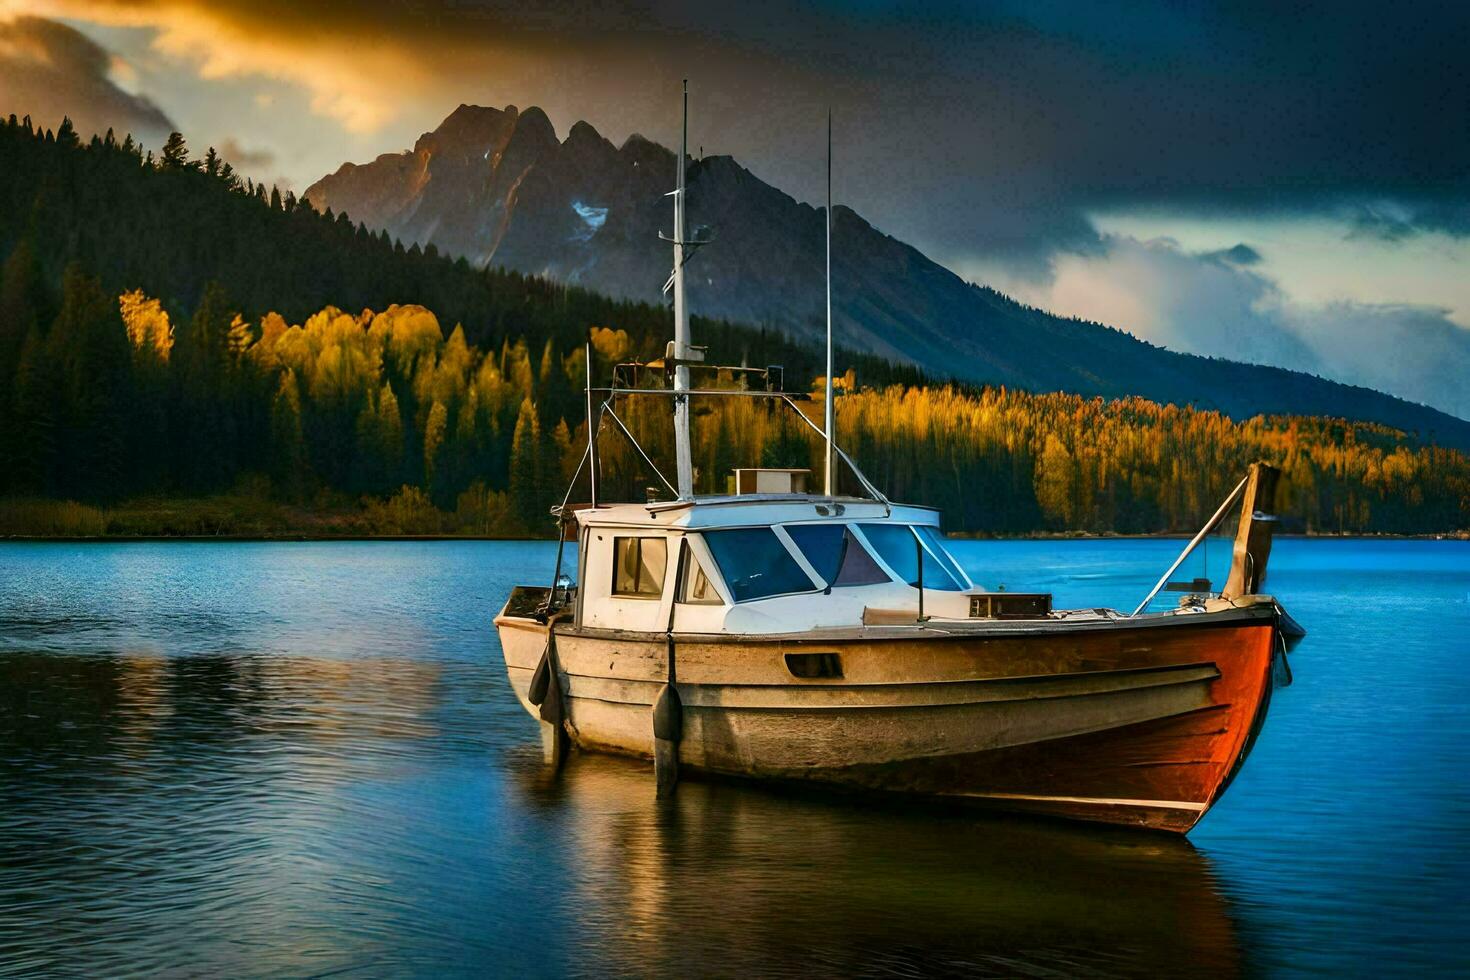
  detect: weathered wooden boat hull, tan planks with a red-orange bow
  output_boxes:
[497,604,1279,833]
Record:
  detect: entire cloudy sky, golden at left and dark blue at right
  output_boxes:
[0,0,1470,417]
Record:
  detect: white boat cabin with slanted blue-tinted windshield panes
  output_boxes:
[576,494,983,633]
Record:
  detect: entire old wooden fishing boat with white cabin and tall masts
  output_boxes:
[494,85,1304,833]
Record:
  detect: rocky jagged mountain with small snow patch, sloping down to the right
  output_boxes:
[306,106,1466,438]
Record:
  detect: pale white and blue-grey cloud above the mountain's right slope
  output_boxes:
[1010,235,1470,419]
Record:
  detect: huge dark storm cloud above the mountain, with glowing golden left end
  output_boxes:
[20,0,1470,266]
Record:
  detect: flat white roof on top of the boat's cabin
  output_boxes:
[576,494,939,529]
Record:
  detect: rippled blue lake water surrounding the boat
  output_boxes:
[0,539,1470,977]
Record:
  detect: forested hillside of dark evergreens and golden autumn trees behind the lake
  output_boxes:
[0,123,1470,533]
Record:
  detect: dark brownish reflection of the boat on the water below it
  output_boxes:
[517,754,1245,976]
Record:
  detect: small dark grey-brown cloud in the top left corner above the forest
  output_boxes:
[0,15,173,143]
